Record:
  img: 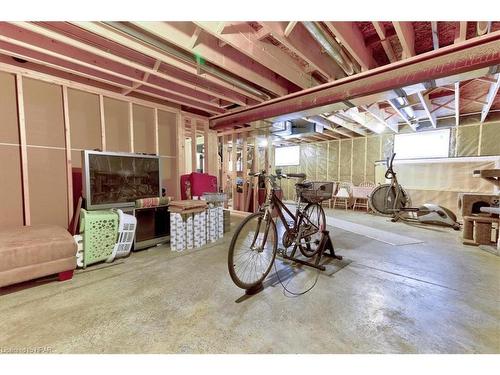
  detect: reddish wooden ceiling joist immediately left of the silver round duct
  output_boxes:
[260,22,345,80]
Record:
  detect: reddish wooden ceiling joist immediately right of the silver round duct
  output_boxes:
[325,22,377,70]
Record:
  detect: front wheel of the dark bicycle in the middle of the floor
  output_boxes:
[227,212,278,289]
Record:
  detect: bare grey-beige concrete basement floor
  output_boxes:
[0,210,500,353]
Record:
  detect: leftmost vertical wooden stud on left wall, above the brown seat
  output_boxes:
[16,74,31,226]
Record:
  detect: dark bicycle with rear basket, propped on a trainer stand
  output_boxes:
[228,170,333,290]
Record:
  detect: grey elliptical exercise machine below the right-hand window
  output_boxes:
[368,153,460,230]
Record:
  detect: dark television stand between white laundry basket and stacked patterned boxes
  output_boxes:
[127,205,170,250]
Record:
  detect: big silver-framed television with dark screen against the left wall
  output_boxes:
[82,150,161,210]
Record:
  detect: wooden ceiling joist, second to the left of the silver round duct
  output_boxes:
[195,21,317,88]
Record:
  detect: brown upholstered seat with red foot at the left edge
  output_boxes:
[0,225,77,287]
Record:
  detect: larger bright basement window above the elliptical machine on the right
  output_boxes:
[394,129,450,159]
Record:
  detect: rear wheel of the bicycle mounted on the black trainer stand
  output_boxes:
[299,203,326,257]
